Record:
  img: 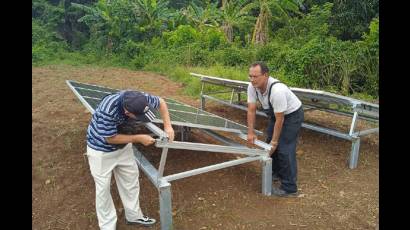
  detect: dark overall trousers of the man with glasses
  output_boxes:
[266,107,304,192]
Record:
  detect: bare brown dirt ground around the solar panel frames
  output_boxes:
[32,65,379,230]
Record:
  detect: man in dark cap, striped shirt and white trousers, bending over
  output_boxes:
[87,91,174,230]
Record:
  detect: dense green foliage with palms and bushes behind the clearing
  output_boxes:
[32,0,379,99]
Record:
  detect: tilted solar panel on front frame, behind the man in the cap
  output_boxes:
[67,81,262,135]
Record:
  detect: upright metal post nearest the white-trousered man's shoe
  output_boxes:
[159,180,172,230]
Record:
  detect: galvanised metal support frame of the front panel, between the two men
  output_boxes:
[137,123,272,230]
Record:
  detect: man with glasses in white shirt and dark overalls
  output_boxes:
[247,62,304,197]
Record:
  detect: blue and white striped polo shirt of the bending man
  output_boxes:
[87,91,159,152]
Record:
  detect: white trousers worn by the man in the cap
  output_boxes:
[87,143,143,230]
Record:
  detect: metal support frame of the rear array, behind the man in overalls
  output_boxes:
[190,73,379,169]
